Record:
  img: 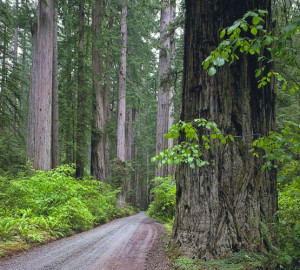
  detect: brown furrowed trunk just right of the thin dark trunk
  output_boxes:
[91,0,107,182]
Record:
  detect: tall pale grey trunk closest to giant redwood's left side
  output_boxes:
[155,0,171,177]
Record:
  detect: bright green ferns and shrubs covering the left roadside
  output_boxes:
[0,165,135,257]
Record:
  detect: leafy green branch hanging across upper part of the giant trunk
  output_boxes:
[202,10,300,94]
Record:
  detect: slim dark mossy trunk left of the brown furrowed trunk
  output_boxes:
[76,1,87,178]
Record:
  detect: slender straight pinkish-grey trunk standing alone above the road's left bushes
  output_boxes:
[117,0,127,161]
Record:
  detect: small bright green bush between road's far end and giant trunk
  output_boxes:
[147,176,176,222]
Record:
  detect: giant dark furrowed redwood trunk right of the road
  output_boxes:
[173,0,277,259]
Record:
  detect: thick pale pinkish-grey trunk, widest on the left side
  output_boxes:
[33,0,54,170]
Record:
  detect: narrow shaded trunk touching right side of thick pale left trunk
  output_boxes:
[52,8,59,168]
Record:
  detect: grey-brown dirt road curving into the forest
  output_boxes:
[0,213,169,270]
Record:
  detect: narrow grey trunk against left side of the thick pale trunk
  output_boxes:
[26,23,38,161]
